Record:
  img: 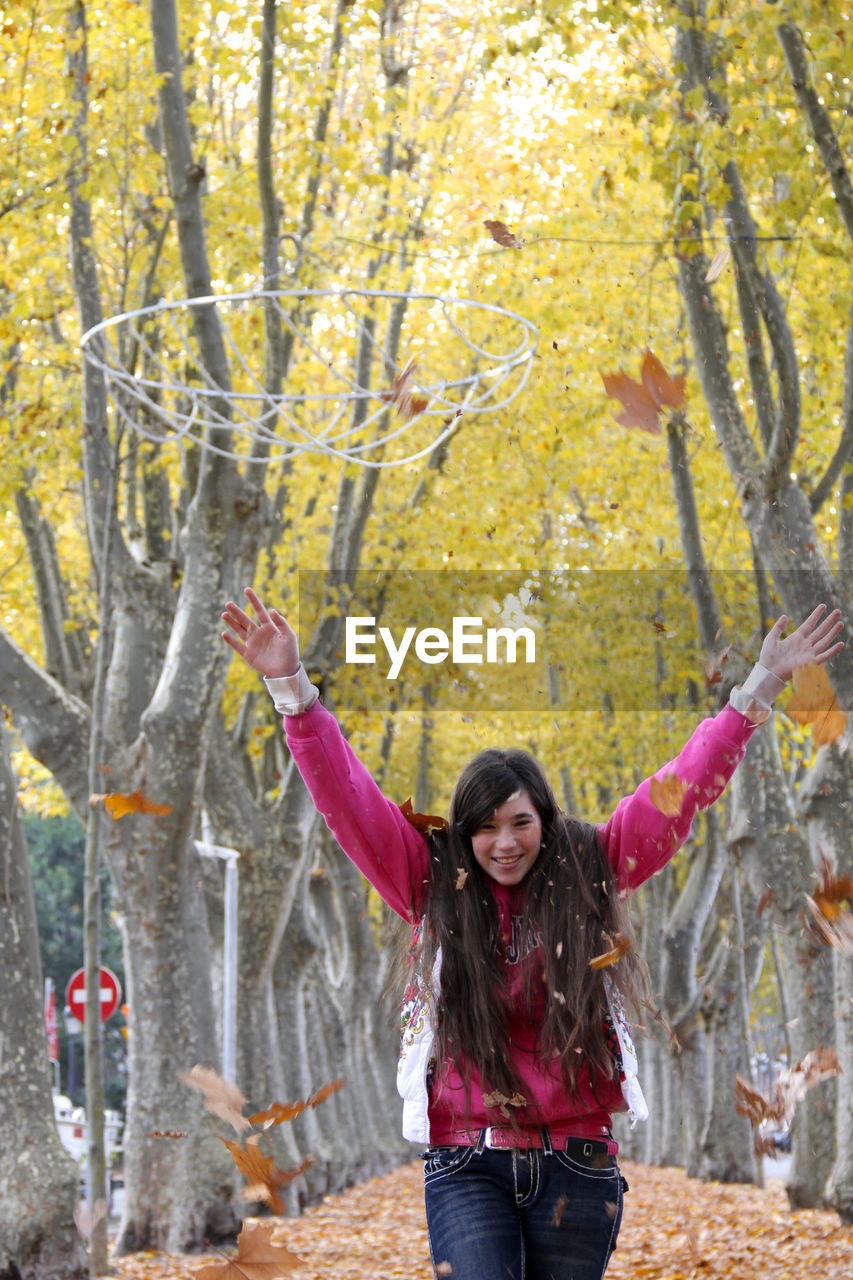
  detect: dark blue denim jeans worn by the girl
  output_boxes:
[424,1135,626,1280]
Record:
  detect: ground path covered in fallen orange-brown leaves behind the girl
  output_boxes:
[108,1162,853,1280]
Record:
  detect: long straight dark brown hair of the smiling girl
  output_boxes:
[420,749,648,1098]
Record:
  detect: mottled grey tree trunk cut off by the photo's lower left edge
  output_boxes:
[0,731,88,1280]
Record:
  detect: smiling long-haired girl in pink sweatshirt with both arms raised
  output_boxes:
[223,589,841,1280]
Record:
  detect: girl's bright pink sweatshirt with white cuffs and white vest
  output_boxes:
[275,667,768,1144]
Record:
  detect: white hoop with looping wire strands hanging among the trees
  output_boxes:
[81,288,538,467]
